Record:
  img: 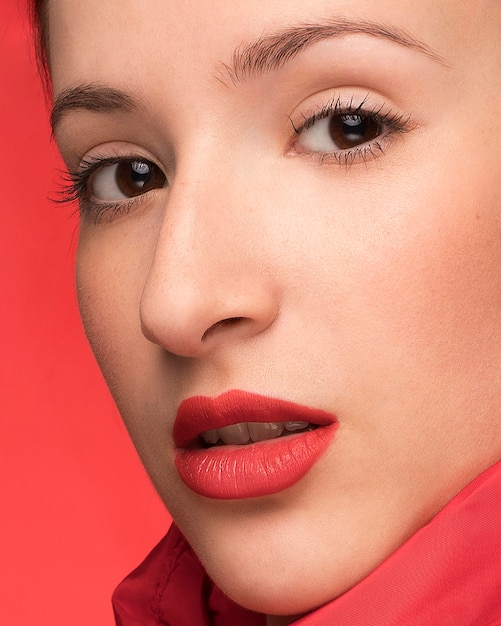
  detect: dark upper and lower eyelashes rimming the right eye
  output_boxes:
[289,95,412,167]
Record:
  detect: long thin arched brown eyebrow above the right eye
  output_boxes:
[220,18,448,84]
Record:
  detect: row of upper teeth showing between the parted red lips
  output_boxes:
[202,421,310,445]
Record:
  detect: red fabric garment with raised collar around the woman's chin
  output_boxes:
[113,462,501,626]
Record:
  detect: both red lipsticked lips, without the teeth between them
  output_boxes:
[174,390,338,500]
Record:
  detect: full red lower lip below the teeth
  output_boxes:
[176,423,338,500]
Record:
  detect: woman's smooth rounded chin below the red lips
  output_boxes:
[180,514,377,616]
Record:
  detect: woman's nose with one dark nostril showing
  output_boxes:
[140,173,279,357]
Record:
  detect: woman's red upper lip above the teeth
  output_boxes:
[173,390,337,448]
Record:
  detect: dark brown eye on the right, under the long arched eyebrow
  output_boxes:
[297,112,382,154]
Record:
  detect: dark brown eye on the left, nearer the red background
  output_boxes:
[88,159,167,202]
